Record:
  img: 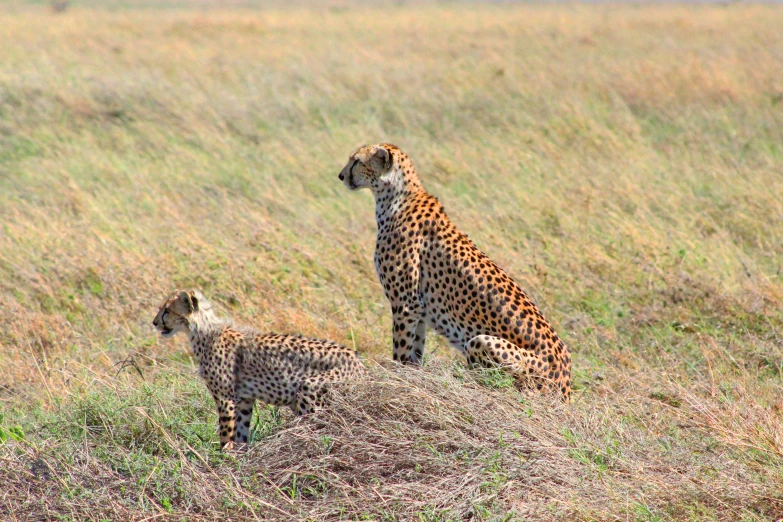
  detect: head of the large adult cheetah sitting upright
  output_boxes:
[338,143,402,193]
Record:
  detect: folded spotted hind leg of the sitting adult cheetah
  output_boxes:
[465,335,551,392]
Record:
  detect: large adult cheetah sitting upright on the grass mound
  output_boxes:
[339,143,571,402]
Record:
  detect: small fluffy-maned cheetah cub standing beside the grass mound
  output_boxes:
[152,290,366,449]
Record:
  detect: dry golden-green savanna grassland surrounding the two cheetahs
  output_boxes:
[0,2,783,521]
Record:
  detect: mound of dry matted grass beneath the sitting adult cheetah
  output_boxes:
[247,363,567,520]
